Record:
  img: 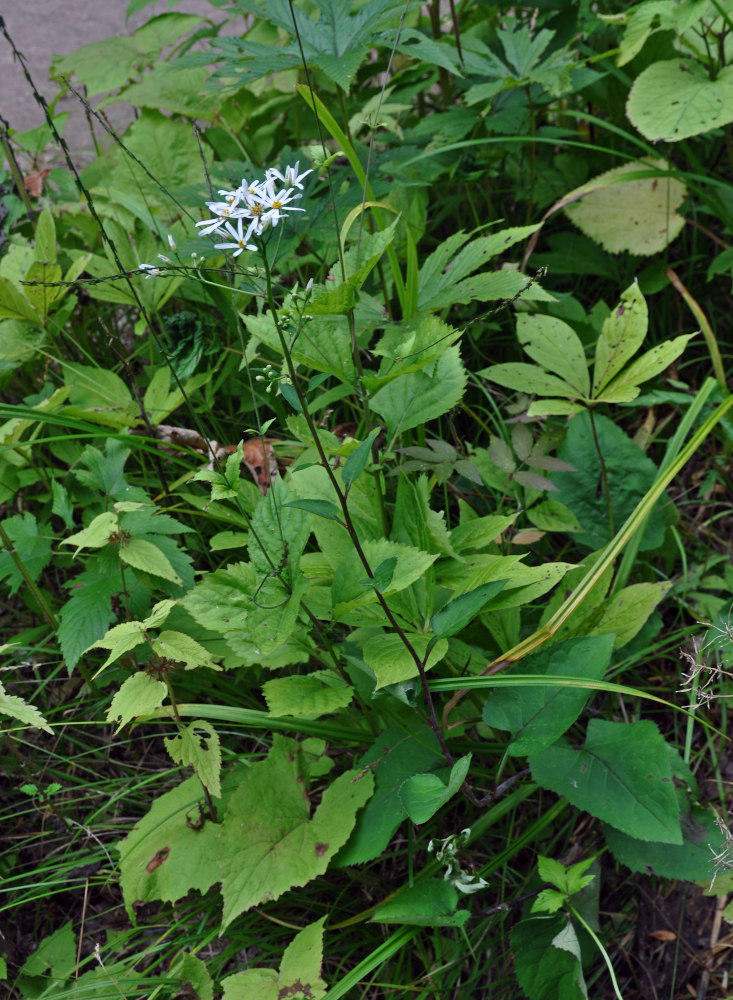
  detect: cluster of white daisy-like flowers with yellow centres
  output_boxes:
[196,161,311,257]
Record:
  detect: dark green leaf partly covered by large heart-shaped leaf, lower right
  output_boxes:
[603,806,726,888]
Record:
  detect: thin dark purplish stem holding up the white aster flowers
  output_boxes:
[262,243,454,767]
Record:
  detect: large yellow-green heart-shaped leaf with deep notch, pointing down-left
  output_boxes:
[220,735,374,927]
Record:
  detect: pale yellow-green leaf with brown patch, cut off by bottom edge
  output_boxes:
[222,917,326,1000]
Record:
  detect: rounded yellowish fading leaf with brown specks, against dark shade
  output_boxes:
[565,159,687,257]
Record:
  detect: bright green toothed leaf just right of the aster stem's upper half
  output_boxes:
[371,345,467,436]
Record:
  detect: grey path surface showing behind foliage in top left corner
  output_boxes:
[0,0,222,167]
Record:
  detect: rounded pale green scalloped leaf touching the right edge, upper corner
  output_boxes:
[626,56,733,142]
